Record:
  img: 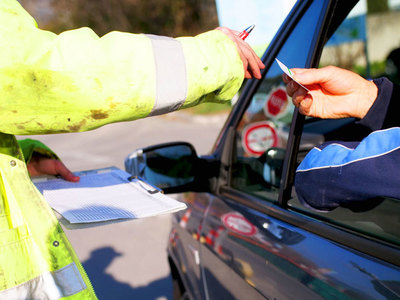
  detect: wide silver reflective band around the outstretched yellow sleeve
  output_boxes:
[146,34,187,116]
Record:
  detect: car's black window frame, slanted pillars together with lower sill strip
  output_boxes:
[214,0,400,266]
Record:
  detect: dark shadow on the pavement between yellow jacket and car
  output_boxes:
[82,247,172,300]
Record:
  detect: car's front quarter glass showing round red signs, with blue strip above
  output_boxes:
[231,1,325,201]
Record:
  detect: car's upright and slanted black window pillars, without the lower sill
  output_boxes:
[213,0,332,199]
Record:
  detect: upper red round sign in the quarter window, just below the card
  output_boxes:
[264,87,289,119]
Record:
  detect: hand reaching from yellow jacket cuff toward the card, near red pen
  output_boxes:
[217,27,265,79]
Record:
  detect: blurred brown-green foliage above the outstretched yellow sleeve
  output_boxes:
[20,0,218,36]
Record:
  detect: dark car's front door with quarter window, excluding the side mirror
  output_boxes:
[197,0,400,299]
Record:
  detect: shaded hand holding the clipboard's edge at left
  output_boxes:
[27,154,80,182]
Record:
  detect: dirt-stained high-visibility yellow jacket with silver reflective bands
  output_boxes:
[0,0,244,299]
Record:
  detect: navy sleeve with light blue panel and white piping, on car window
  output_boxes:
[295,127,400,211]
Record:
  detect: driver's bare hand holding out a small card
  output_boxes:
[283,66,378,119]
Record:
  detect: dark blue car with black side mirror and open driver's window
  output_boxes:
[127,0,400,299]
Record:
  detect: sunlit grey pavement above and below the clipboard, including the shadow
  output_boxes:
[21,112,225,299]
